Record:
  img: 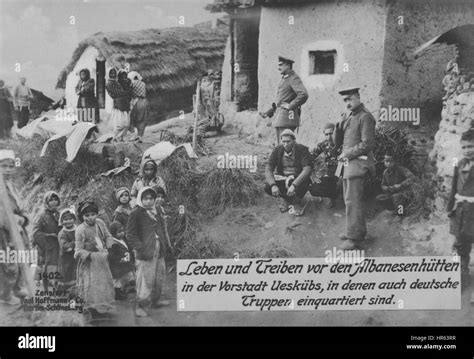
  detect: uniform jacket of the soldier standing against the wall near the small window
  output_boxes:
[266,70,308,127]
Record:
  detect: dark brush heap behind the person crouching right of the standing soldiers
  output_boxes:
[374,126,418,183]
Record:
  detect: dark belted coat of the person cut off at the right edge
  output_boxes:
[447,158,474,237]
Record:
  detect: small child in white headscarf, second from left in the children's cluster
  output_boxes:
[58,208,76,293]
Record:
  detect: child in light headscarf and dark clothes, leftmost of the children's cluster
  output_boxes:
[33,191,61,291]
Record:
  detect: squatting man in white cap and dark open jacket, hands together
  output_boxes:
[265,129,312,216]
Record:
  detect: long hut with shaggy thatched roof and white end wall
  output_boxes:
[56,18,228,123]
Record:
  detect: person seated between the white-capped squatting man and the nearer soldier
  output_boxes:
[309,123,342,208]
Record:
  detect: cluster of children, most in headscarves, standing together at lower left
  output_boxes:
[32,160,171,317]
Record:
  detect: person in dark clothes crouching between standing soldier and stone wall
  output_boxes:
[376,153,415,215]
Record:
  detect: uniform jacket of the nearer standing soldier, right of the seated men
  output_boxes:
[335,103,375,179]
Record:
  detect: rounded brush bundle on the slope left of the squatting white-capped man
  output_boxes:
[198,168,261,217]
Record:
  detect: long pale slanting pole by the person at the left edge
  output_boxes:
[0,167,35,298]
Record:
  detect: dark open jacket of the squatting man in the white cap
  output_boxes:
[265,143,312,186]
